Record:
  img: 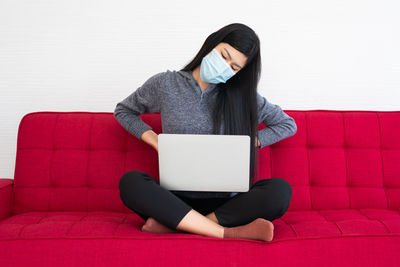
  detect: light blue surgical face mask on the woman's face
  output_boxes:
[200,48,236,83]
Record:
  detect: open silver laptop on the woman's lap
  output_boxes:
[158,133,250,192]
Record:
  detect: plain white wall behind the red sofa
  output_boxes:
[0,0,400,178]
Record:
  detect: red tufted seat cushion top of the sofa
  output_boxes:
[0,209,400,243]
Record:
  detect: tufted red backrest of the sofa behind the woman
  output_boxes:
[13,110,400,214]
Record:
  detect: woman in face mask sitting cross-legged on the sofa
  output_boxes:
[114,23,297,241]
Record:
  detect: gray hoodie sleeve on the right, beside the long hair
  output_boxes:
[257,93,297,148]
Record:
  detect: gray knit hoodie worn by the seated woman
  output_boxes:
[114,70,297,198]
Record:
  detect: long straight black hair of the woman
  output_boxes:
[181,23,261,186]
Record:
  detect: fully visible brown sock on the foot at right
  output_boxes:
[224,218,274,244]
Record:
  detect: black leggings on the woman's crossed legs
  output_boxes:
[119,171,292,229]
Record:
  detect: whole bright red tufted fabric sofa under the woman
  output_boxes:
[0,110,400,266]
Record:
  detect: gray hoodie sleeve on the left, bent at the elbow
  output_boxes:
[114,72,167,140]
